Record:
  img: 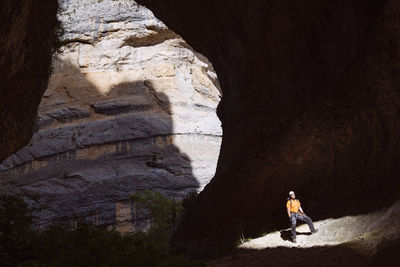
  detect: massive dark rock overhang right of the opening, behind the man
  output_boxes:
[2,0,399,256]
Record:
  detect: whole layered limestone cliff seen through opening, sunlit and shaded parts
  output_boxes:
[0,0,222,232]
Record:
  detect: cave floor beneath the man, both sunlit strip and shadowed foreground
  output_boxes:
[209,201,400,266]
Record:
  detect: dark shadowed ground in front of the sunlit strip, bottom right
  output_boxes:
[209,239,400,267]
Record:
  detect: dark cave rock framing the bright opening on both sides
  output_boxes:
[0,0,400,266]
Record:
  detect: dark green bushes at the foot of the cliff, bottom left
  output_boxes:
[0,194,204,267]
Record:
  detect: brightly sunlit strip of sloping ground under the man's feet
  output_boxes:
[239,201,400,255]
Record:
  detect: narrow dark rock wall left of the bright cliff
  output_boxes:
[0,0,58,162]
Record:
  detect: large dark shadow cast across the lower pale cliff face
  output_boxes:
[0,59,200,231]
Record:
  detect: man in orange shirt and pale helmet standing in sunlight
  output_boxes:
[286,191,318,243]
